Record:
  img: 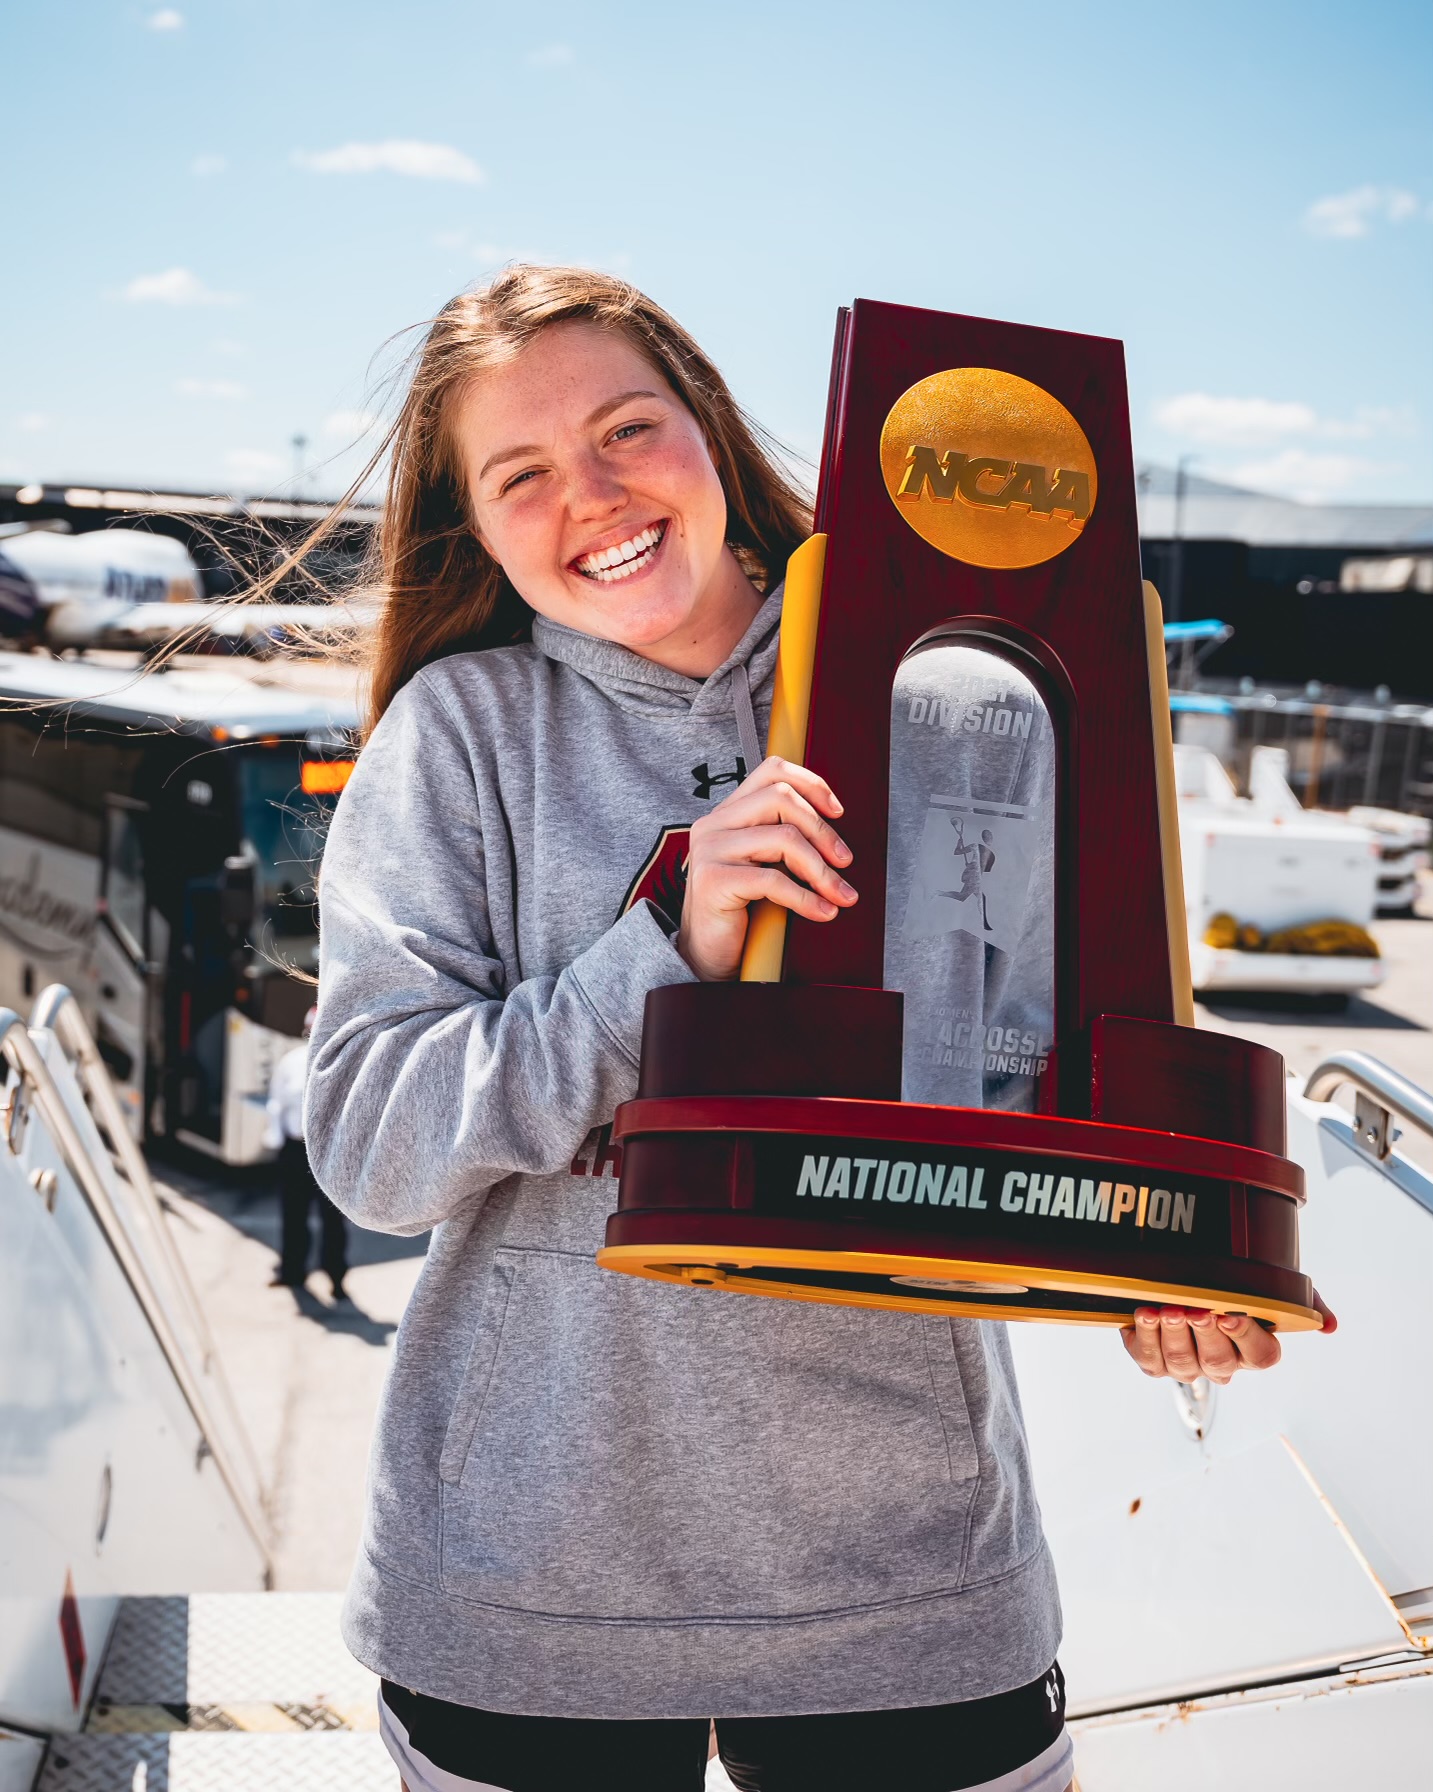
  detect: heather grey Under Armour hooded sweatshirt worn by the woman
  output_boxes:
[306,593,1059,1719]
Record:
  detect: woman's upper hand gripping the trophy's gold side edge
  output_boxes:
[677,760,856,984]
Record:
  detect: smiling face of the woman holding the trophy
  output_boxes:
[455,323,761,677]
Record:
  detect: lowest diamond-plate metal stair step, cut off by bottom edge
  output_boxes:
[36,1733,398,1792]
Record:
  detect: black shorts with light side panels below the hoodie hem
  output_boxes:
[380,1663,1073,1792]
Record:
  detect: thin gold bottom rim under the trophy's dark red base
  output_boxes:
[596,1222,1324,1331]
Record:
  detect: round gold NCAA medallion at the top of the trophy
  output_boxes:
[881,367,1096,568]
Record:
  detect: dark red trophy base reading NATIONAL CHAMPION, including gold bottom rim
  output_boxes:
[596,984,1322,1331]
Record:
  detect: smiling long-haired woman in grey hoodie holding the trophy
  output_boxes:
[290,267,1089,1792]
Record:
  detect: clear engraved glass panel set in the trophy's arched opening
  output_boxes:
[885,640,1055,1113]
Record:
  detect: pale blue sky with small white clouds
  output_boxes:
[0,0,1433,502]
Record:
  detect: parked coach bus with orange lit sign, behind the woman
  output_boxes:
[0,652,358,1163]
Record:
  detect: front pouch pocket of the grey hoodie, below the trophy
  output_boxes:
[441,1249,980,1622]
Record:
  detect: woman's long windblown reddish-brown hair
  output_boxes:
[256,265,811,729]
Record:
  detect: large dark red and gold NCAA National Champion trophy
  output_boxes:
[598,299,1320,1330]
